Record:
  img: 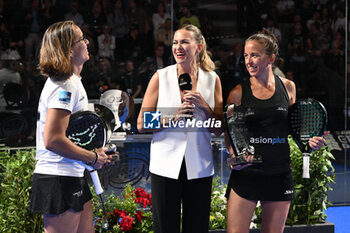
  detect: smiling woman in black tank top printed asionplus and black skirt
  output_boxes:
[226,30,325,233]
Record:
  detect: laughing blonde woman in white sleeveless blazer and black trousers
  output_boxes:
[137,25,223,233]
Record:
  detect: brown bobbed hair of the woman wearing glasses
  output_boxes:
[38,20,77,80]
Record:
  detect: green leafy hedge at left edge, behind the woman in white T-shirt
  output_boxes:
[0,150,43,233]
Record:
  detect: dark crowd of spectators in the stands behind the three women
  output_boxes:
[0,0,348,144]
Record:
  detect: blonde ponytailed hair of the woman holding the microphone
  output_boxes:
[180,24,215,72]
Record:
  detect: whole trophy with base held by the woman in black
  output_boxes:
[224,104,262,167]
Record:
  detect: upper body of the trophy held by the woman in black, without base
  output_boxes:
[224,104,249,156]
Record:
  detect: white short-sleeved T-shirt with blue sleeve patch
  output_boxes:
[34,74,88,177]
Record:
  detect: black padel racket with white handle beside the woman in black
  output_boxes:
[288,98,328,178]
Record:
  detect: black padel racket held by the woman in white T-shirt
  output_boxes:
[66,111,115,229]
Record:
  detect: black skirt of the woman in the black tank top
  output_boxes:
[225,170,294,201]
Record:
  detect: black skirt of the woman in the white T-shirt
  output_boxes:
[29,173,92,215]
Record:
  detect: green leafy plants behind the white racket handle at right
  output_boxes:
[287,137,335,225]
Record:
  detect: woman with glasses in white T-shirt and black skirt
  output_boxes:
[30,21,110,233]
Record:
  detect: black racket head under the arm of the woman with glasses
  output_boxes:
[66,111,107,150]
